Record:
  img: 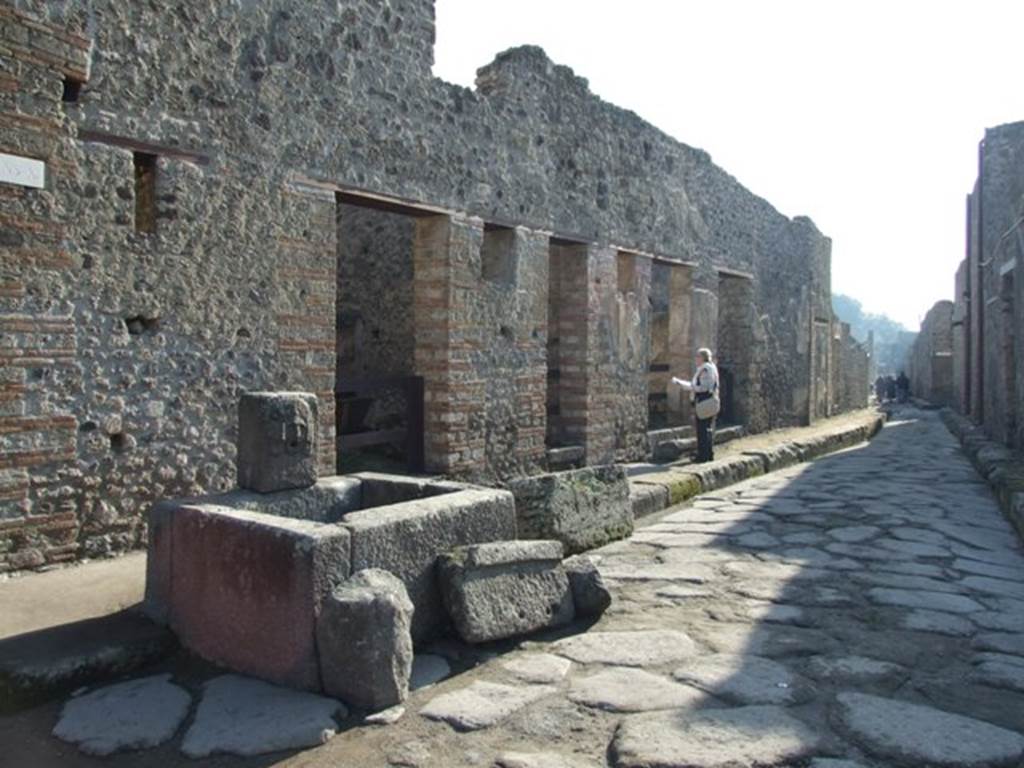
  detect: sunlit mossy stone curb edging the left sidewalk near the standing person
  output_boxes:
[630,413,886,518]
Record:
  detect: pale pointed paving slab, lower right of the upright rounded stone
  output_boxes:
[420,680,558,731]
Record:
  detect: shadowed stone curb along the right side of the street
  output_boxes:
[939,408,1024,542]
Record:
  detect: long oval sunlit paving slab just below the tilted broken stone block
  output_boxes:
[552,630,696,667]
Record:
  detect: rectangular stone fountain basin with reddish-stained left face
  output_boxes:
[145,472,516,690]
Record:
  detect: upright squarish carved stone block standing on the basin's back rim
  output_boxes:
[238,392,318,494]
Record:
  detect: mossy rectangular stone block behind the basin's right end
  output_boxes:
[509,465,633,554]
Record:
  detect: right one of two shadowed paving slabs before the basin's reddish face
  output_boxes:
[181,675,348,758]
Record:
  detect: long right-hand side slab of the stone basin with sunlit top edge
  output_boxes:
[344,488,516,641]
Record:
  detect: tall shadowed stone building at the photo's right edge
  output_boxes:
[951,122,1024,446]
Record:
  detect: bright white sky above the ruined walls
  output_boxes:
[434,0,1024,330]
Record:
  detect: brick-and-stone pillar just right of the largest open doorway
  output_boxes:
[413,215,485,475]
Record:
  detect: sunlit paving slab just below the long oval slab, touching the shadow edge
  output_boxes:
[569,667,714,712]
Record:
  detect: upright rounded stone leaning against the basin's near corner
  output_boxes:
[316,568,413,712]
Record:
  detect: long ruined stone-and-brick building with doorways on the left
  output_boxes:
[0,0,862,569]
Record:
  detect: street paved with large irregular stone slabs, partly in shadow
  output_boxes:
[276,411,1024,768]
